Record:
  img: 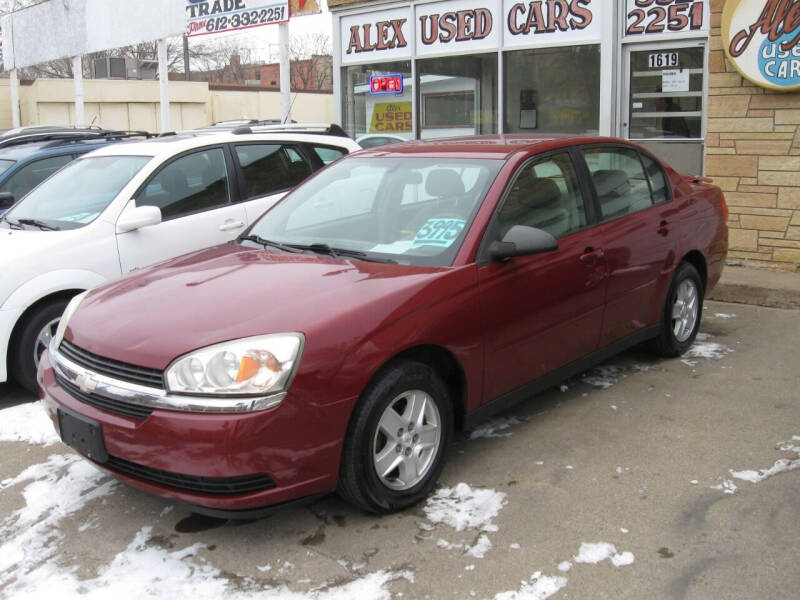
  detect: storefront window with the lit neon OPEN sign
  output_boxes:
[342,60,413,143]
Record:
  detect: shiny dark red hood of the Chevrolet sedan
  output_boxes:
[66,244,462,369]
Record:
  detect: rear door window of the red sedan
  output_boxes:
[583,148,653,221]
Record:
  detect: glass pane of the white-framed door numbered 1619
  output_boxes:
[630,47,704,139]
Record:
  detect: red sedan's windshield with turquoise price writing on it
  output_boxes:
[250,157,503,267]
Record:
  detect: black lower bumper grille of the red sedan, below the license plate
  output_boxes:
[102,455,276,496]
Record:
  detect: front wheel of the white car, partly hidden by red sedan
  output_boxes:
[9,299,69,394]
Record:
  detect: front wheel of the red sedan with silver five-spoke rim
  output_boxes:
[338,360,453,513]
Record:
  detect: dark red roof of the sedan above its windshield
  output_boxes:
[358,133,627,159]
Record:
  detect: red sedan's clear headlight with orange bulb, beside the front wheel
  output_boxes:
[166,333,305,396]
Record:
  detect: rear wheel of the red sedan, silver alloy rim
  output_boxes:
[651,262,704,357]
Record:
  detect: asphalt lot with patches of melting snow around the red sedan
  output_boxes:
[0,301,800,600]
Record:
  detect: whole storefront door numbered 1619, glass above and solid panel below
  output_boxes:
[621,42,706,174]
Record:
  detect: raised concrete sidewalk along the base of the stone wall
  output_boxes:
[708,266,800,309]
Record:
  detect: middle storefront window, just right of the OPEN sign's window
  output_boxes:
[417,54,497,139]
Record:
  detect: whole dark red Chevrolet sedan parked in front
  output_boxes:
[38,136,727,516]
